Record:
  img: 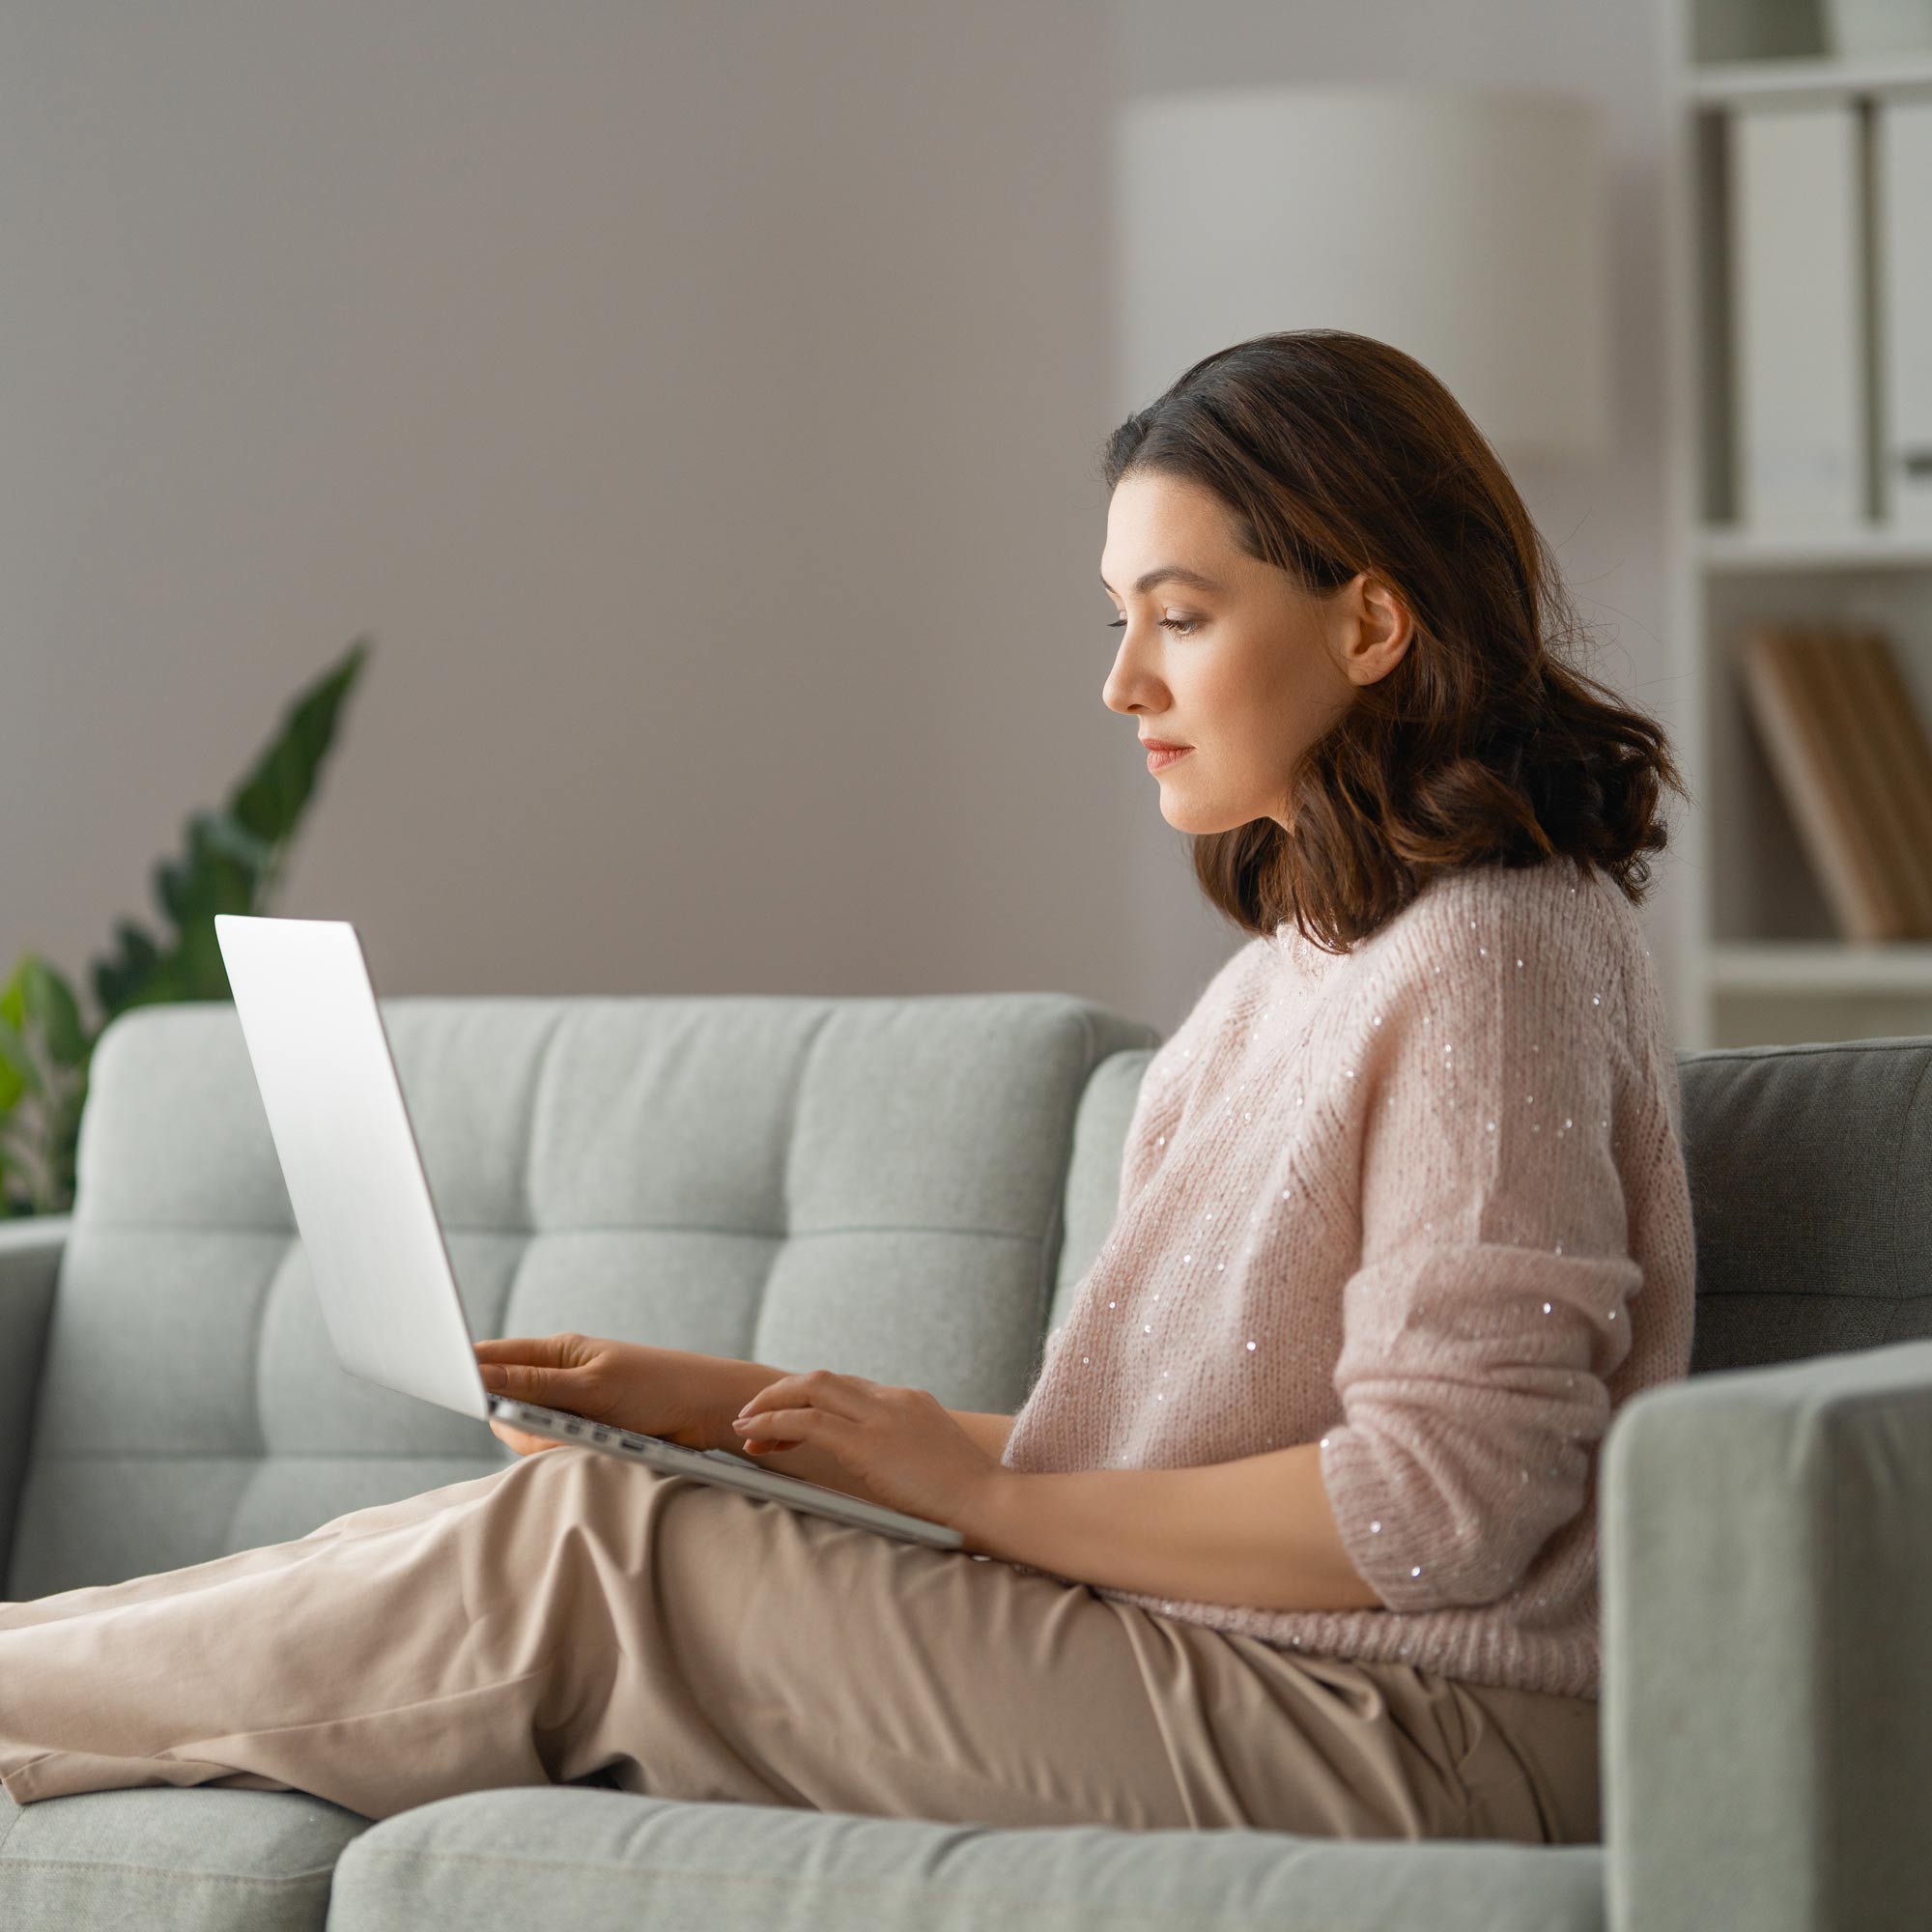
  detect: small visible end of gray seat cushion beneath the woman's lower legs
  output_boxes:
[0,1785,369,1932]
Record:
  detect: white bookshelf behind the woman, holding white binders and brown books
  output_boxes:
[1662,0,1932,1049]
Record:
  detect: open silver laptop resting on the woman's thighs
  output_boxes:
[214,912,964,1549]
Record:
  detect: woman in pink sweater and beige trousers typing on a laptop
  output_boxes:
[0,330,1692,1843]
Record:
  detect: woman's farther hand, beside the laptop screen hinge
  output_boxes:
[471,1329,721,1455]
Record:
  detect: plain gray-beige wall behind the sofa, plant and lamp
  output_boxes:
[0,0,1681,1032]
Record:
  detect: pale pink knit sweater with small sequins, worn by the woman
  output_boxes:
[1003,860,1692,1696]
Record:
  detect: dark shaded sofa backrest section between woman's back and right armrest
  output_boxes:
[1677,1037,1932,1374]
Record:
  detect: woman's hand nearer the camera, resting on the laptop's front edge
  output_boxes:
[732,1368,1003,1528]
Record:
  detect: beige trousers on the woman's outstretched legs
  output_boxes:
[0,1445,1600,1843]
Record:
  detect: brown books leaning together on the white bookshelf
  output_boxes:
[1737,624,1932,941]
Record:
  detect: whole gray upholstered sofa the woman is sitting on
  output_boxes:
[0,993,1932,1932]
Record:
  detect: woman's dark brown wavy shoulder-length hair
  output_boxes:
[1103,328,1690,952]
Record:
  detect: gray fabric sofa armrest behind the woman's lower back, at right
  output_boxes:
[1600,1341,1932,1932]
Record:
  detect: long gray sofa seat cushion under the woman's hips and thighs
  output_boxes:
[328,1785,1605,1932]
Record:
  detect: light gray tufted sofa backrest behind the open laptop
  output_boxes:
[0,993,1159,1600]
